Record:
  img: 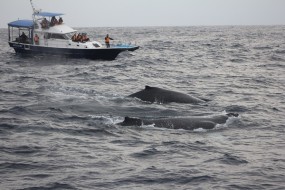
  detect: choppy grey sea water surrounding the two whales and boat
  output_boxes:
[0,26,285,190]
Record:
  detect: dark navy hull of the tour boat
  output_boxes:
[9,42,139,60]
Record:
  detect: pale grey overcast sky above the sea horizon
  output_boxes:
[0,0,285,28]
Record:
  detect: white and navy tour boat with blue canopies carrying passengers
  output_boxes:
[8,0,139,60]
